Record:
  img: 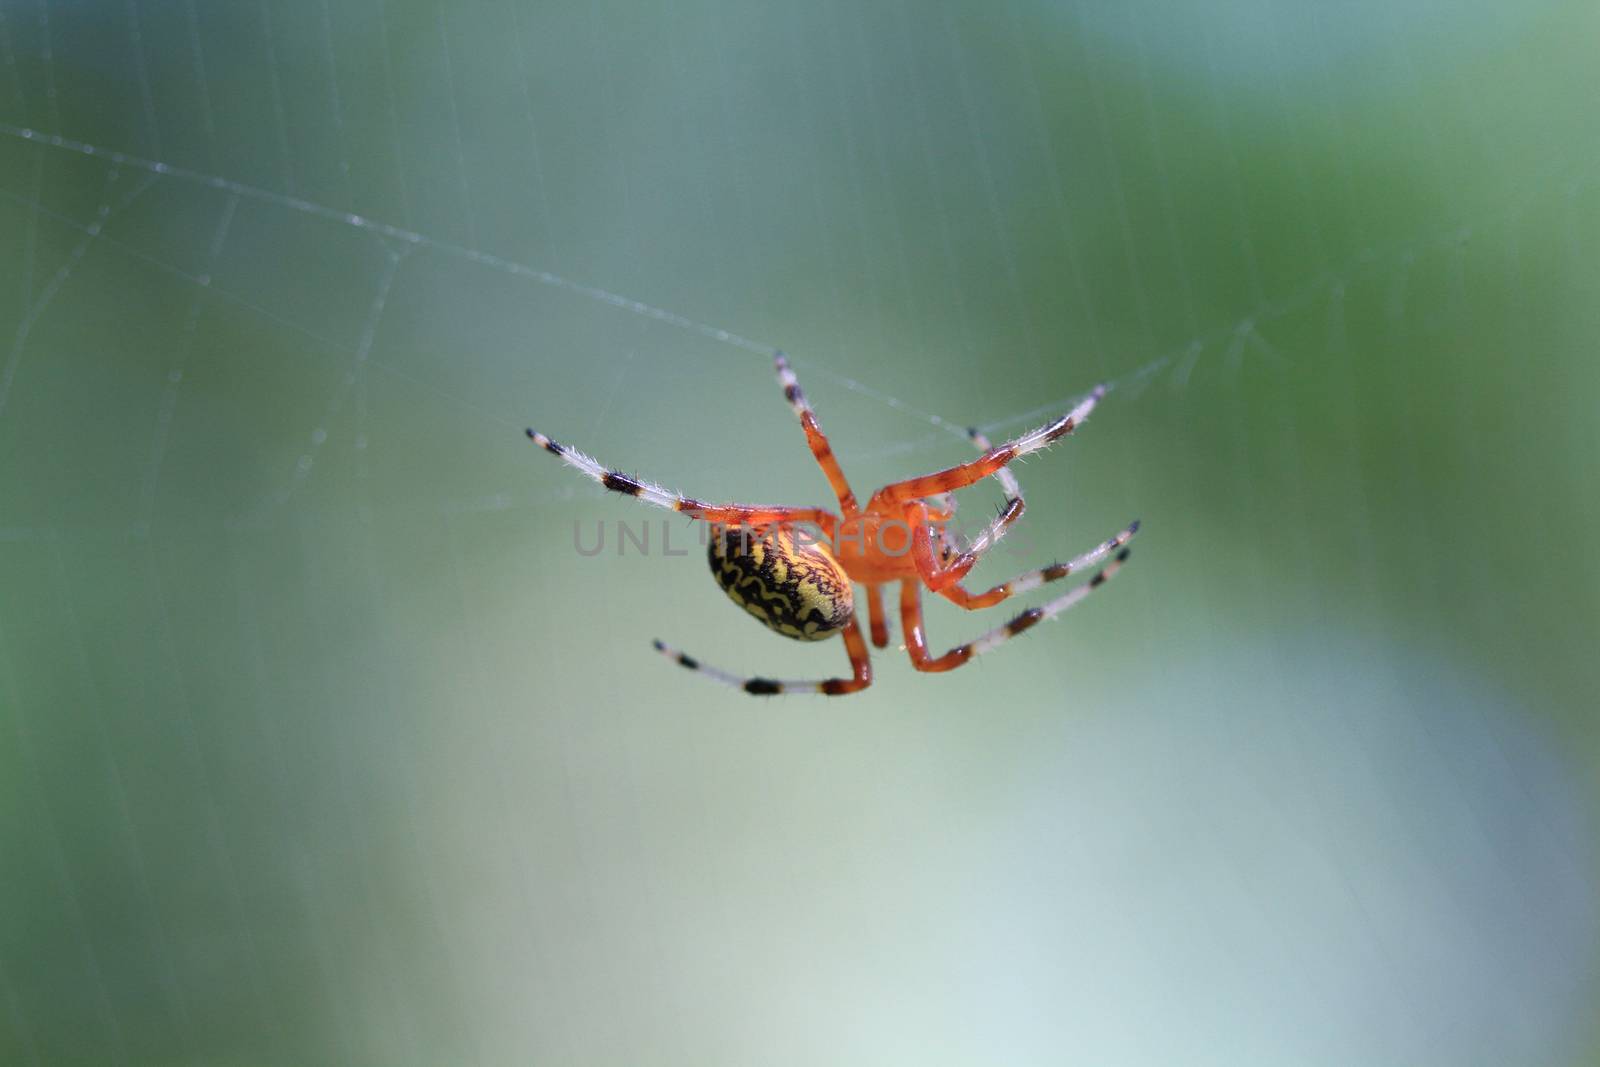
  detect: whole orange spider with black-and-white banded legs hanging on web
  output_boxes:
[528,352,1139,696]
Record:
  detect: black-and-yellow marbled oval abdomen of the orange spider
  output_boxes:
[709,526,854,641]
